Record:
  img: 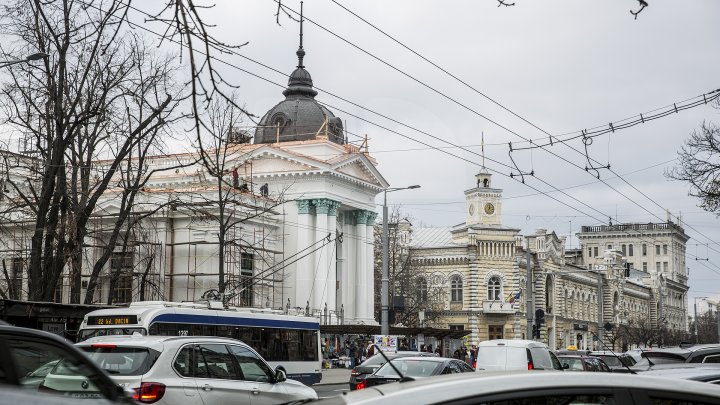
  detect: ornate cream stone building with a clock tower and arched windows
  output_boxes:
[406,170,687,349]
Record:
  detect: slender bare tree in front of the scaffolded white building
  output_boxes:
[179,97,286,306]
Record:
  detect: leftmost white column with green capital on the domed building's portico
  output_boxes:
[292,200,315,308]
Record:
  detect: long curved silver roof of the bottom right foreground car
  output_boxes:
[319,371,720,404]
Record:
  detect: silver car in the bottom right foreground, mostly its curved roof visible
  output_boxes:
[318,371,720,405]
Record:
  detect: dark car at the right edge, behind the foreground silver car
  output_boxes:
[632,343,720,371]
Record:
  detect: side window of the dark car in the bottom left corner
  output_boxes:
[7,338,105,398]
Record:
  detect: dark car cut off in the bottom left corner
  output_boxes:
[0,325,133,404]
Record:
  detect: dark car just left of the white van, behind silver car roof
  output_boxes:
[357,356,475,389]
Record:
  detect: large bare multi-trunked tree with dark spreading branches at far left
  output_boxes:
[1,0,183,303]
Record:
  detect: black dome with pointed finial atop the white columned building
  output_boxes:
[254,46,345,145]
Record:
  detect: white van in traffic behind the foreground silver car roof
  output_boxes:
[475,339,563,371]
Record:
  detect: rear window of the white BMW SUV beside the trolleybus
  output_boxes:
[81,346,158,375]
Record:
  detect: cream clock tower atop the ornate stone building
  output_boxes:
[465,168,502,225]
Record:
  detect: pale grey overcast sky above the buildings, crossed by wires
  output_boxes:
[163,0,720,304]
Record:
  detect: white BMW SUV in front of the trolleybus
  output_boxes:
[77,335,317,405]
